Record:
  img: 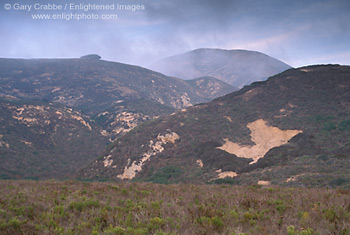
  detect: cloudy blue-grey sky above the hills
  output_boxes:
[0,0,350,67]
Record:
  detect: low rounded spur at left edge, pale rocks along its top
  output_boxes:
[0,98,108,179]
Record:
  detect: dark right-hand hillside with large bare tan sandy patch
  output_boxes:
[79,65,350,187]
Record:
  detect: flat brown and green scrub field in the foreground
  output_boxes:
[0,181,350,235]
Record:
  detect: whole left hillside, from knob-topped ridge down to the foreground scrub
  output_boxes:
[0,55,235,179]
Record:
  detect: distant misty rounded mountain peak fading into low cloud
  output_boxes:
[150,49,291,87]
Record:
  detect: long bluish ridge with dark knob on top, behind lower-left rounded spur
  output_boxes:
[0,55,235,139]
